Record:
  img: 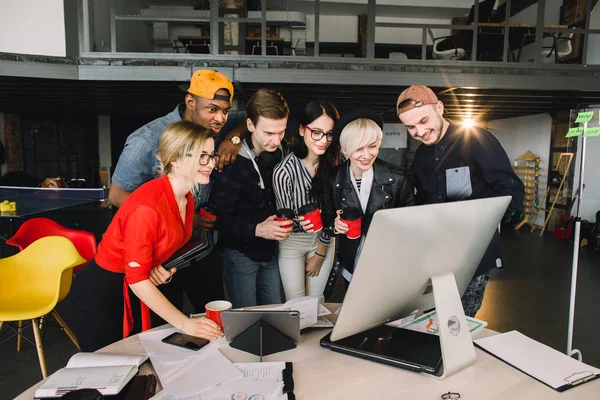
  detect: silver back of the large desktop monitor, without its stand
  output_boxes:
[331,196,510,341]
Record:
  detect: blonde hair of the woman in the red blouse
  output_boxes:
[156,121,212,180]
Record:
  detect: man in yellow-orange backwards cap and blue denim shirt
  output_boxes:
[108,70,246,323]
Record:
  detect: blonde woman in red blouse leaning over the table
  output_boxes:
[71,121,223,351]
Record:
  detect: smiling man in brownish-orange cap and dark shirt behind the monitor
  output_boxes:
[396,86,525,317]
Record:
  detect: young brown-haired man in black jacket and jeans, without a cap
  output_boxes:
[210,89,292,308]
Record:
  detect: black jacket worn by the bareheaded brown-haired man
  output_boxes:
[210,156,277,261]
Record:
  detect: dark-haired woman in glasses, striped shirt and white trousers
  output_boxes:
[273,101,339,300]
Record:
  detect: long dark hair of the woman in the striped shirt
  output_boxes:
[290,100,340,203]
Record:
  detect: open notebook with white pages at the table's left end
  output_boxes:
[35,353,148,398]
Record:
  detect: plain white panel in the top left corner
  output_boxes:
[0,0,67,57]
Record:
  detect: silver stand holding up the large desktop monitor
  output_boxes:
[426,273,475,379]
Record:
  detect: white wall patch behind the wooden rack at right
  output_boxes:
[489,114,552,225]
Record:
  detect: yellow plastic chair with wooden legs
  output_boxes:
[0,236,85,378]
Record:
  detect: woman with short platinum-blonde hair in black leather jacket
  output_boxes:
[322,109,414,282]
